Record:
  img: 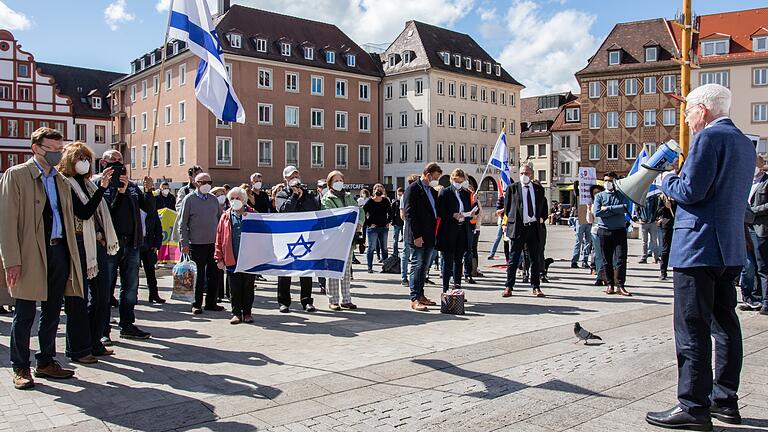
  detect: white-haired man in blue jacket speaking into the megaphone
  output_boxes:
[646,84,756,431]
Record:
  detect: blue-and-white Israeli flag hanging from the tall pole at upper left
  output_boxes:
[168,0,245,123]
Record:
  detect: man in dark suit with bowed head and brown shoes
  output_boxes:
[404,162,443,312]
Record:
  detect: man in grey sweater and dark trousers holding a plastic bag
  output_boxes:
[179,173,224,315]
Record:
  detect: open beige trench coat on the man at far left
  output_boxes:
[0,159,83,301]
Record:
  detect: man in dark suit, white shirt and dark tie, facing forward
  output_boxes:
[502,165,549,297]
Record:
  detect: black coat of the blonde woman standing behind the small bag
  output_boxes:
[435,187,472,253]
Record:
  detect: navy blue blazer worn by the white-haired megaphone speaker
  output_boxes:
[661,119,756,268]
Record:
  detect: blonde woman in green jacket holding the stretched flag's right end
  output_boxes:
[320,171,365,311]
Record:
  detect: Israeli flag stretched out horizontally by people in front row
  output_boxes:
[235,207,360,279]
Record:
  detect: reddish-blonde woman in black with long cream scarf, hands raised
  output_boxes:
[57,142,120,364]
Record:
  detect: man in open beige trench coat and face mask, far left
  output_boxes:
[0,128,83,389]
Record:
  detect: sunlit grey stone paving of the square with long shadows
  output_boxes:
[0,227,768,432]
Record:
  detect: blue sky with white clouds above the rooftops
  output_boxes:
[0,0,768,96]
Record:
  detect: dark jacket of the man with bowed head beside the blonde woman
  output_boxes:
[403,179,437,247]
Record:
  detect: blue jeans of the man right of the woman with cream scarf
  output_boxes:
[104,245,139,337]
